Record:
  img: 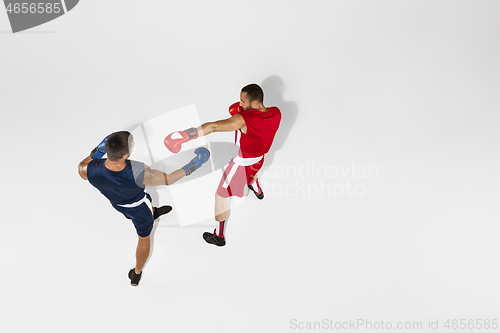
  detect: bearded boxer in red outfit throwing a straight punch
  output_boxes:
[165,84,281,246]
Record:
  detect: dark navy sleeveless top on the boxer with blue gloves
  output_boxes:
[87,159,145,205]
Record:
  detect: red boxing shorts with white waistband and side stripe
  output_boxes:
[217,157,264,198]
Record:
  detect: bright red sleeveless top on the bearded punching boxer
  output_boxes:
[237,106,281,158]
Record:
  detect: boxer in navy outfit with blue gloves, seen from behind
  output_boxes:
[78,131,210,286]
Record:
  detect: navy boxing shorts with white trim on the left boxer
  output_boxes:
[113,193,154,237]
